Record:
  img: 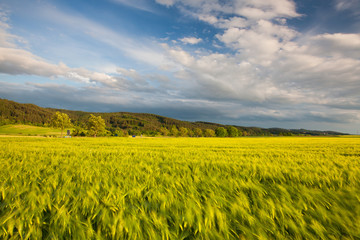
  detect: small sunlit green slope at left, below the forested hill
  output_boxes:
[0,124,66,136]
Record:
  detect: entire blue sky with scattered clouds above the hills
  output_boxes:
[0,0,360,134]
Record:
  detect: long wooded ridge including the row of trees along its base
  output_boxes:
[0,98,344,137]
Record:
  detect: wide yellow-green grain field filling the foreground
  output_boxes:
[0,137,360,239]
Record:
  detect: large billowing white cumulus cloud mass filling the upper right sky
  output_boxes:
[157,0,359,103]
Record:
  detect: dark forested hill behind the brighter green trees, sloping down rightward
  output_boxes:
[0,99,343,136]
